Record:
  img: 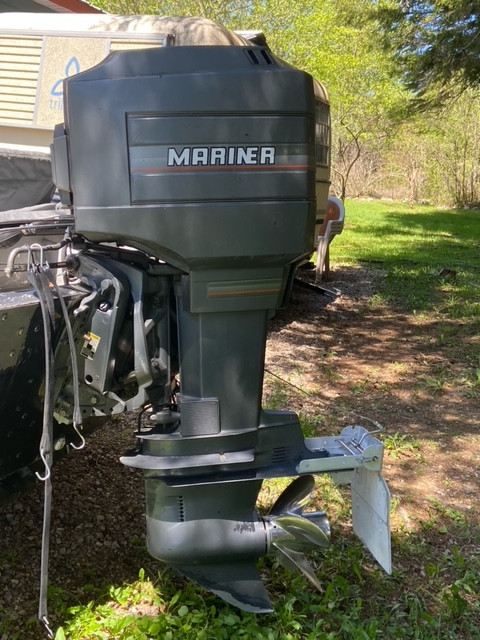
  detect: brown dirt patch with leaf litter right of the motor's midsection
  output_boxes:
[266,266,480,527]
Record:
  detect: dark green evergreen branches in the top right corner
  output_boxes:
[374,0,480,107]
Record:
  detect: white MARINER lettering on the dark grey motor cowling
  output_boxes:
[167,146,275,167]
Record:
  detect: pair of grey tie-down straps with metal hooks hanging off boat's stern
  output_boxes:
[27,252,85,639]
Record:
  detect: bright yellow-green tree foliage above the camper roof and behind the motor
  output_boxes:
[97,0,405,198]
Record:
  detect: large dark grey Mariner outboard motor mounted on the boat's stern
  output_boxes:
[44,38,391,612]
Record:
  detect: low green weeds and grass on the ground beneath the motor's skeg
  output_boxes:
[52,539,479,640]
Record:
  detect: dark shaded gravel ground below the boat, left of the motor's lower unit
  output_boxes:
[0,417,155,640]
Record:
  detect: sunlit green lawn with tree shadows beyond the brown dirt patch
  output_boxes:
[331,201,480,323]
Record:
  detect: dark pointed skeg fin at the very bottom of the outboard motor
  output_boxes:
[175,561,273,613]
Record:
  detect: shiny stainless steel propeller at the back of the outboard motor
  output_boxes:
[264,476,330,590]
